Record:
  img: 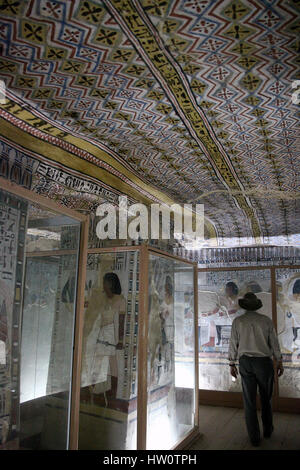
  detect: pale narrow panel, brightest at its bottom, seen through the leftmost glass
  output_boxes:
[20,257,59,403]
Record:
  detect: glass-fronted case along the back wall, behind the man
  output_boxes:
[198,265,300,412]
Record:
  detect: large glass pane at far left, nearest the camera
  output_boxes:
[0,191,80,449]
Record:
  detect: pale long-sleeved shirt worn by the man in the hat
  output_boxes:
[228,311,282,362]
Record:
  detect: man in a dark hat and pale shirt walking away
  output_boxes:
[228,292,283,447]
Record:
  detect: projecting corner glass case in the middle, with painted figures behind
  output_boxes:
[79,246,198,450]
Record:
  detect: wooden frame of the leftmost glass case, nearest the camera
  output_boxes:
[0,177,89,450]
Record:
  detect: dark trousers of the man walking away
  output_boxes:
[239,356,274,441]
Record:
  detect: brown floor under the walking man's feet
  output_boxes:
[189,406,300,450]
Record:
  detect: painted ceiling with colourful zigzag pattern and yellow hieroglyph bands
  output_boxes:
[0,0,300,246]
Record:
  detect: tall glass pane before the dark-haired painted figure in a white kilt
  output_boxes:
[79,251,139,450]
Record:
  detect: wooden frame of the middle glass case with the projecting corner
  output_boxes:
[87,244,200,450]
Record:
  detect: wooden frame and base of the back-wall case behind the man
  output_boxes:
[198,264,300,413]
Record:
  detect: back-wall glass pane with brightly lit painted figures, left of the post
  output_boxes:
[198,270,272,392]
